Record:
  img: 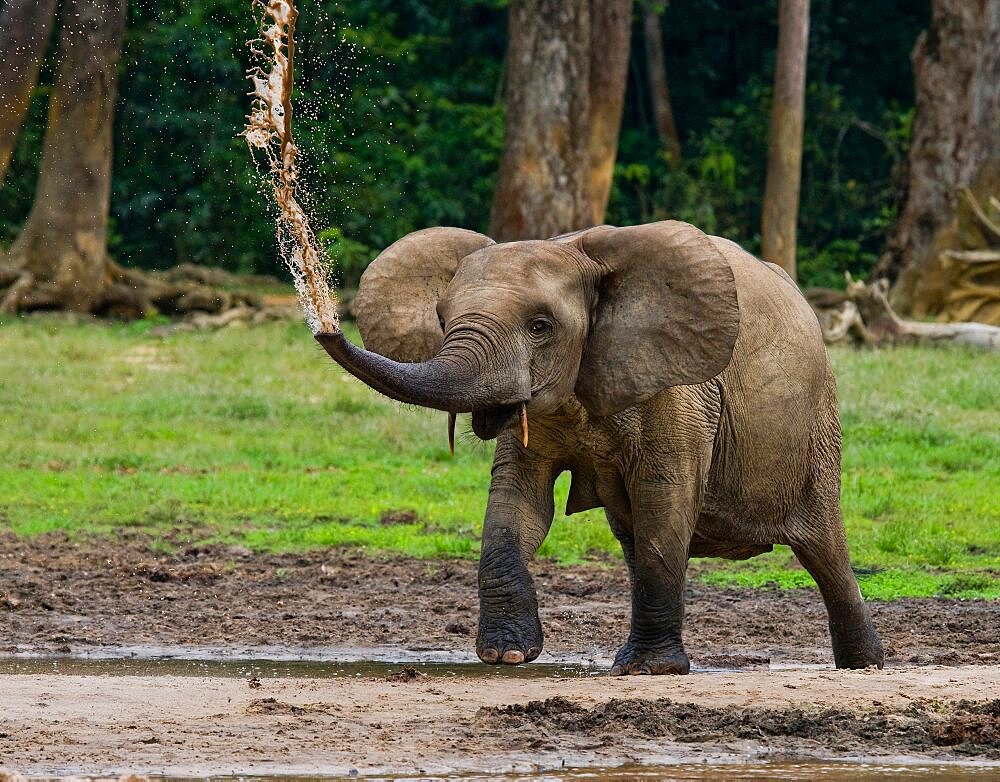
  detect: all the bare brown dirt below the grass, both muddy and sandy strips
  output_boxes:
[0,535,1000,775]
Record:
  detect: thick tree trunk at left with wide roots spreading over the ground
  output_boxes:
[0,0,286,328]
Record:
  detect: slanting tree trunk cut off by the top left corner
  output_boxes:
[0,0,56,187]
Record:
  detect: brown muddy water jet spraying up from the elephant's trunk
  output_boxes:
[242,0,340,334]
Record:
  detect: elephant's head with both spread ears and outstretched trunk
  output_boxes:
[316,221,739,439]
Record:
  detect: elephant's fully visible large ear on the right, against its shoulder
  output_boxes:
[576,220,739,416]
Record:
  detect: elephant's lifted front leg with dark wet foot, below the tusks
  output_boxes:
[476,434,555,665]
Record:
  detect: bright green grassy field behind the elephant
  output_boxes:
[0,317,1000,599]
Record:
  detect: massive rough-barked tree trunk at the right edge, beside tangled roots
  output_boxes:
[875,0,1000,318]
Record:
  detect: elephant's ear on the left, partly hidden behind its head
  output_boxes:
[354,228,494,362]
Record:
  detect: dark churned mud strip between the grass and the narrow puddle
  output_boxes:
[0,534,1000,668]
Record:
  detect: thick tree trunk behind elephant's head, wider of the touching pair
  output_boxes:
[490,0,592,241]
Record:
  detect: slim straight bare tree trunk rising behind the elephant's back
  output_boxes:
[761,0,809,280]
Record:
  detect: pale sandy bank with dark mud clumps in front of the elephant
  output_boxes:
[0,666,1000,776]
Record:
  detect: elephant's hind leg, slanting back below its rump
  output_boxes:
[792,524,885,668]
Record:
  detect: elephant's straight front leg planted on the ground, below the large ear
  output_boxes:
[611,476,701,676]
